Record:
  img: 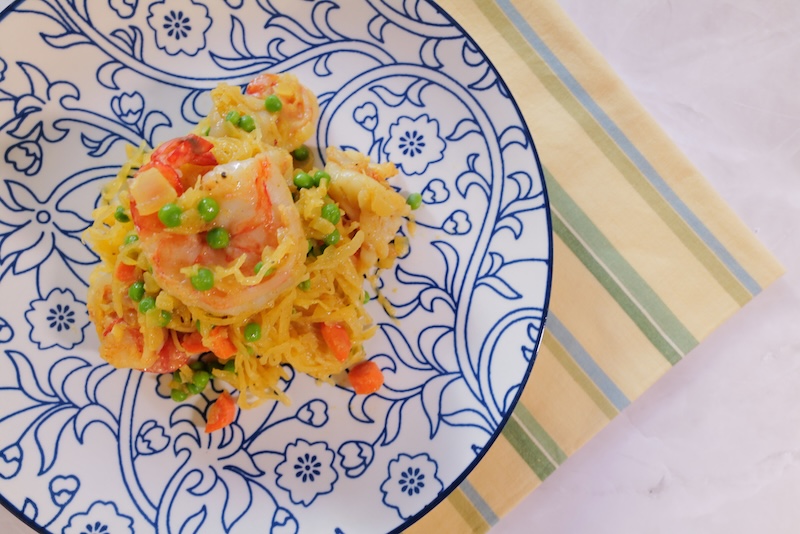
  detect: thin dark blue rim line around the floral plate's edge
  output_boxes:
[0,0,553,534]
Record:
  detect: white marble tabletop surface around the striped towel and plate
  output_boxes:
[0,0,800,534]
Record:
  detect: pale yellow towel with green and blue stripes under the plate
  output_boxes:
[409,0,782,533]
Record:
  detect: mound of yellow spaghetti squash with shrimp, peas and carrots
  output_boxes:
[85,74,418,422]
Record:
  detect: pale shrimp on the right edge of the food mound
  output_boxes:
[325,147,411,268]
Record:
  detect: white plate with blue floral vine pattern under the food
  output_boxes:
[0,0,552,534]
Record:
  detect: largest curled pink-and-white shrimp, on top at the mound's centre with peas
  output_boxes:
[141,151,308,316]
